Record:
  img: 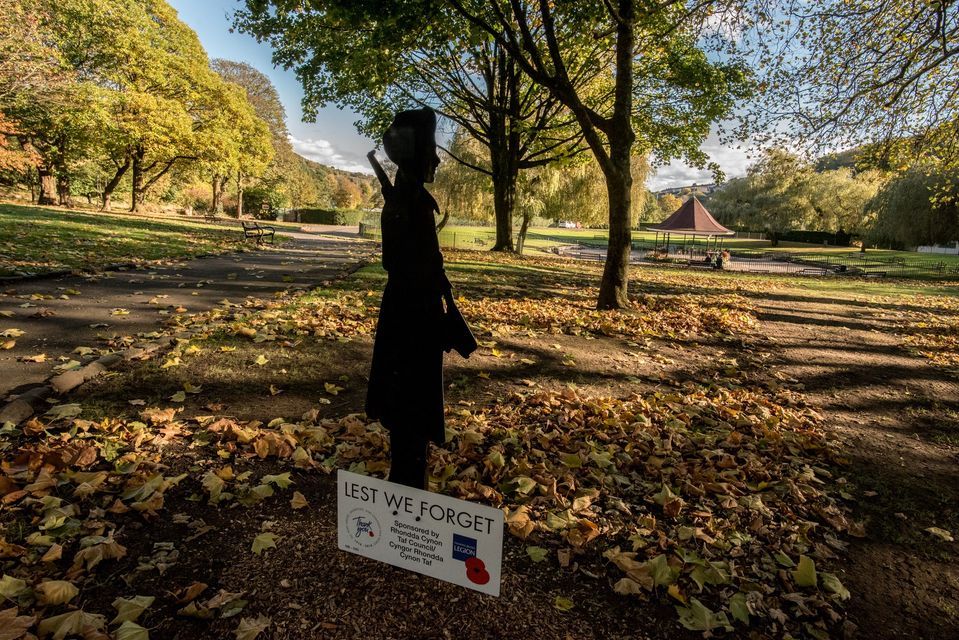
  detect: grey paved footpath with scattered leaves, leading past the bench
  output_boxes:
[0,229,375,401]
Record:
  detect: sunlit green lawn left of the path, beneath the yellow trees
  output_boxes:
[0,205,262,276]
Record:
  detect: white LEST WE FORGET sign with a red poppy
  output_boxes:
[336,469,503,596]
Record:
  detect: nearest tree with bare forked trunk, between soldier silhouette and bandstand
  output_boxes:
[447,0,749,309]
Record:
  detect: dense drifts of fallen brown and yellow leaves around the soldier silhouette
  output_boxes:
[0,249,851,637]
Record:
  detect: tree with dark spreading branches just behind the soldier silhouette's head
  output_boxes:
[237,0,597,251]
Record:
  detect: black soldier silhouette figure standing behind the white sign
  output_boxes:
[366,108,476,489]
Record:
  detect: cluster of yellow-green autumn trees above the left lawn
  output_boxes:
[0,0,278,214]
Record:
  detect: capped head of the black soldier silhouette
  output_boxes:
[383,107,440,183]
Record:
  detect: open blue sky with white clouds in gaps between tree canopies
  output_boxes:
[168,0,749,191]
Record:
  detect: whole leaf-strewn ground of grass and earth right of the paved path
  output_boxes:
[0,251,959,639]
